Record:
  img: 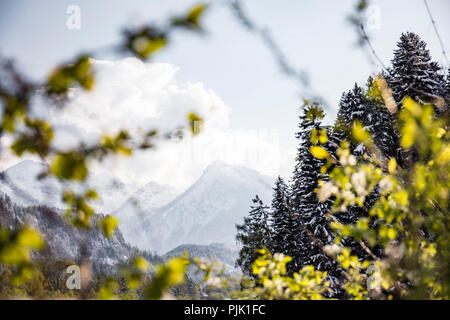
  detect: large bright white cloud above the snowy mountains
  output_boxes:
[1,58,280,189]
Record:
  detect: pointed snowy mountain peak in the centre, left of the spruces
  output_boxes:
[117,162,273,253]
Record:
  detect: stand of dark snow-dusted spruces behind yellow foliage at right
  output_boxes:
[240,33,444,297]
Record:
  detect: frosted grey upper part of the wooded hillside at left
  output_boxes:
[0,194,142,273]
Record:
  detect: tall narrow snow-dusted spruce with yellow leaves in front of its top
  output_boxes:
[291,106,342,294]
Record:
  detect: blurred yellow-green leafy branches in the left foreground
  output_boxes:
[0,3,207,298]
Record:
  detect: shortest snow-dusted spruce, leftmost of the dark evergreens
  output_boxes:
[236,196,271,277]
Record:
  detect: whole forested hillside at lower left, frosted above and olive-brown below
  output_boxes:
[0,194,163,298]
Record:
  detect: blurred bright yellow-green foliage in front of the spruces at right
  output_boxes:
[318,97,450,299]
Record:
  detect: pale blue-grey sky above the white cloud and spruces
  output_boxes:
[0,0,450,186]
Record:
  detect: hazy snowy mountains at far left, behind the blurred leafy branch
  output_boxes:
[0,160,131,213]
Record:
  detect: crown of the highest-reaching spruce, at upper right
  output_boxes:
[385,32,444,107]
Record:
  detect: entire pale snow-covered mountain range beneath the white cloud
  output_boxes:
[0,160,273,253]
